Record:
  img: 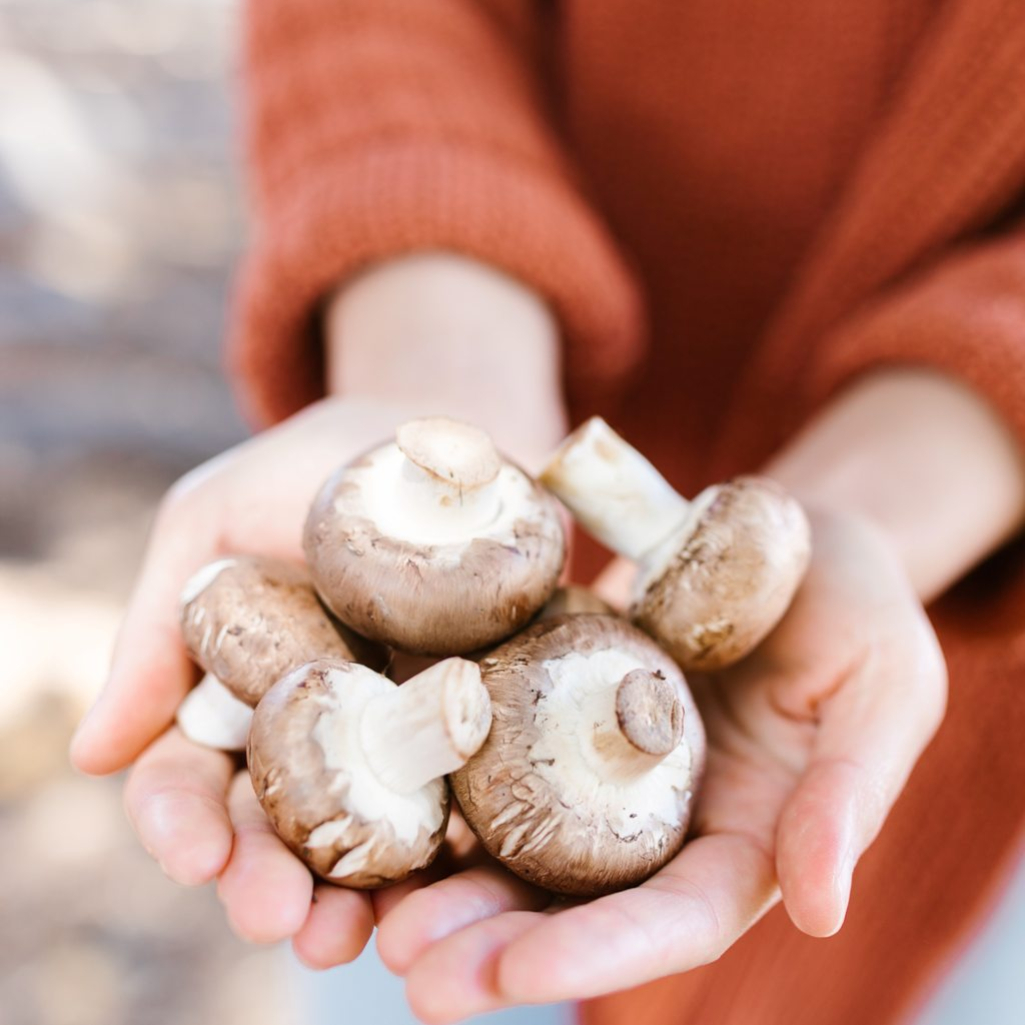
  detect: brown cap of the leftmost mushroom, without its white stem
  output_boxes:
[180,556,385,705]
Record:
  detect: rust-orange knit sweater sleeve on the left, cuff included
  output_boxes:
[229,0,642,423]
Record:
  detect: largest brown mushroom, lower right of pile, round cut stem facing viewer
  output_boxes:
[451,613,705,897]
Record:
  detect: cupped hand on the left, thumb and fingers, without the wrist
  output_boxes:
[72,399,434,964]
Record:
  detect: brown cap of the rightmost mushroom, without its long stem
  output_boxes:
[630,477,811,671]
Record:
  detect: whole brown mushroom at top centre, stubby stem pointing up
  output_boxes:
[304,417,566,656]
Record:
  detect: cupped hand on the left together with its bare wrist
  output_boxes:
[72,254,564,968]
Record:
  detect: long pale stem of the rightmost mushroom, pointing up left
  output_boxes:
[539,416,691,561]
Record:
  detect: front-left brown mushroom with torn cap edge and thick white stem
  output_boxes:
[248,658,491,889]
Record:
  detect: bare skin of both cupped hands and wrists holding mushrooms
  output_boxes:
[73,255,1025,1022]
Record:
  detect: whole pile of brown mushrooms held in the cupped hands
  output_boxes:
[170,417,808,896]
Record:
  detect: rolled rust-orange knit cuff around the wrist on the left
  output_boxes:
[229,139,643,424]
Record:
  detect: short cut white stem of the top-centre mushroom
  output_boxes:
[394,416,501,539]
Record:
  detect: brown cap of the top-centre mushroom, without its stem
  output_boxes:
[303,442,566,656]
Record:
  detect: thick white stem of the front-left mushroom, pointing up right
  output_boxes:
[360,658,491,793]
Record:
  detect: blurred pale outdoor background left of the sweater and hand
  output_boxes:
[0,0,289,1025]
